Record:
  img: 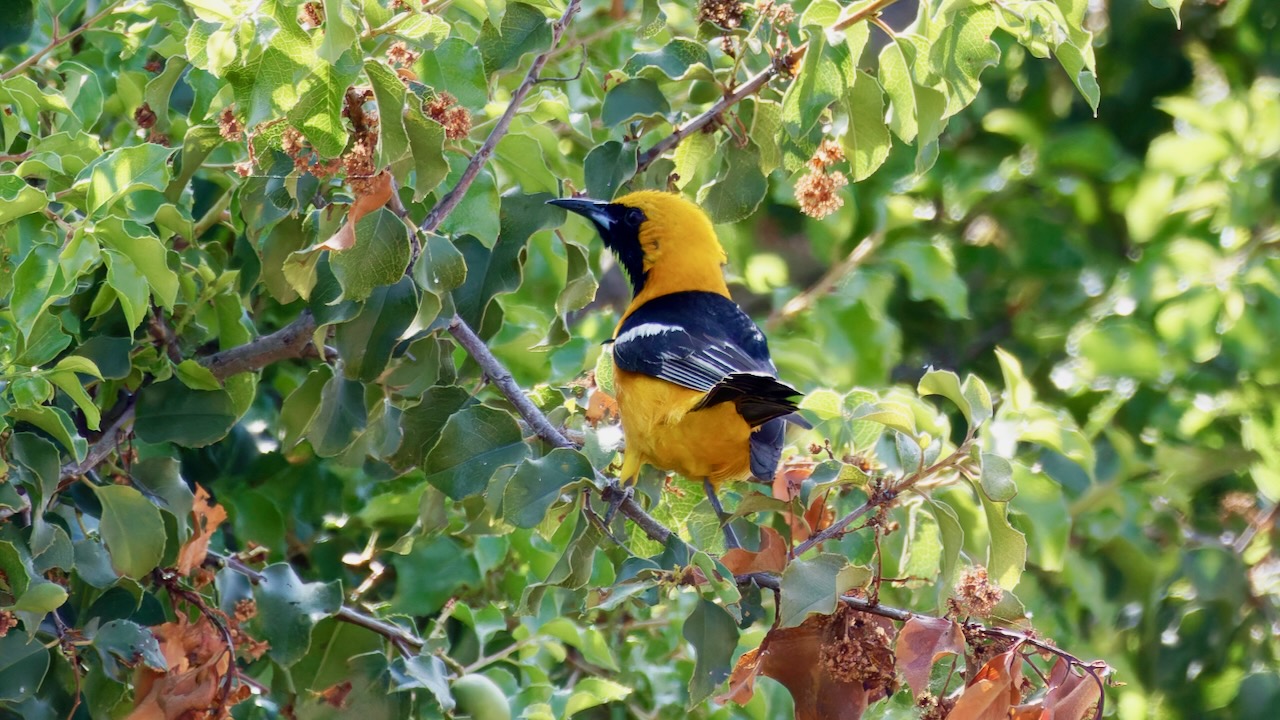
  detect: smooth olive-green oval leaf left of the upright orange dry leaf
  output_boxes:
[93,486,165,579]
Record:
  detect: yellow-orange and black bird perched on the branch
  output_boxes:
[550,191,808,544]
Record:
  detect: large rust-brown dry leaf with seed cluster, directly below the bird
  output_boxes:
[717,607,893,720]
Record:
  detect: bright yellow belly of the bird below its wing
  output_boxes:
[617,370,751,486]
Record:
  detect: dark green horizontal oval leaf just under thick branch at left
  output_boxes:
[133,379,238,447]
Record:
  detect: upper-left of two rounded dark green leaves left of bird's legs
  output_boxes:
[422,405,529,500]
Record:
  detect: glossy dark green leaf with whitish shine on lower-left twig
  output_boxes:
[253,562,342,667]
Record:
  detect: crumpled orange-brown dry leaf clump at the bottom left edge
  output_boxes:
[128,615,246,720]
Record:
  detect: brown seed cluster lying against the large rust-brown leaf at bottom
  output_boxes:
[819,606,897,697]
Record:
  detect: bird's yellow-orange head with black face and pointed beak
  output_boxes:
[550,190,728,297]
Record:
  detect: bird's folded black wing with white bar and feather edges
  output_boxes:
[613,291,800,428]
